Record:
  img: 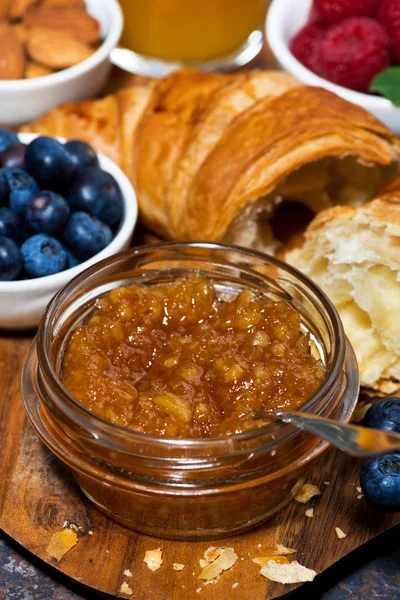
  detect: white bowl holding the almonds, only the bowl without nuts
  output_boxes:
[0,0,123,127]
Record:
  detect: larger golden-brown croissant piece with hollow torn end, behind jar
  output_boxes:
[23,69,400,251]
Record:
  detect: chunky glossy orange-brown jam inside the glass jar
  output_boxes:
[63,275,325,438]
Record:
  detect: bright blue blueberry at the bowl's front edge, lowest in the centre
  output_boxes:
[21,233,67,277]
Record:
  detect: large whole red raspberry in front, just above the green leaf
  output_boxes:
[318,17,390,92]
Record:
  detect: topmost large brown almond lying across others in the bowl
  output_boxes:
[25,6,100,44]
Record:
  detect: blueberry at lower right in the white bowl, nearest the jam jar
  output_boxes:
[63,212,113,260]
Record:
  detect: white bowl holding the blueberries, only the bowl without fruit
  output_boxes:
[0,133,138,329]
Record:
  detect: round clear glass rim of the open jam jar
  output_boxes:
[36,241,348,449]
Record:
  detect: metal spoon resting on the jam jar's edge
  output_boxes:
[265,411,400,457]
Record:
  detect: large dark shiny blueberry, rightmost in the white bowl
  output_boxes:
[67,169,123,225]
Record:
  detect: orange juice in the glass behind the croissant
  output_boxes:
[119,0,266,62]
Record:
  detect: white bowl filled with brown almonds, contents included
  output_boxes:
[0,0,123,126]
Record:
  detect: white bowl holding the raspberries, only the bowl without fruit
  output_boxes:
[266,0,400,133]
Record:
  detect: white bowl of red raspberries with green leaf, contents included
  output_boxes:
[266,0,400,133]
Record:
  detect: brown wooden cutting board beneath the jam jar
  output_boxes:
[0,335,400,600]
